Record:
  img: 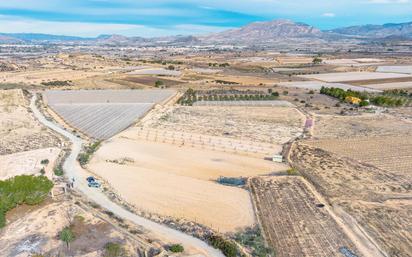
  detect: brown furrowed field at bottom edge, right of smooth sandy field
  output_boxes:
[250,177,357,257]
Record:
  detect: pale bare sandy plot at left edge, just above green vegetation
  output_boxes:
[0,148,60,180]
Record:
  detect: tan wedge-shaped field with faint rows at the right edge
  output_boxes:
[307,136,412,179]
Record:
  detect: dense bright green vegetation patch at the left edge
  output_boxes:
[0,175,53,227]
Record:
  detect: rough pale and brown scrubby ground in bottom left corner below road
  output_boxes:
[0,201,153,257]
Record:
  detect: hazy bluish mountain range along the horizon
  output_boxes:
[0,20,412,45]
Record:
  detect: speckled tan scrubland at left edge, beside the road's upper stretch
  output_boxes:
[0,89,61,155]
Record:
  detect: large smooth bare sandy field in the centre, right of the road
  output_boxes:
[88,135,266,232]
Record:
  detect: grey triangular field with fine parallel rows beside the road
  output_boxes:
[51,104,152,139]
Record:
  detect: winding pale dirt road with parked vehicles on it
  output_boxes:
[30,93,224,257]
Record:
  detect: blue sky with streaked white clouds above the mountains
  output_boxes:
[0,0,412,37]
